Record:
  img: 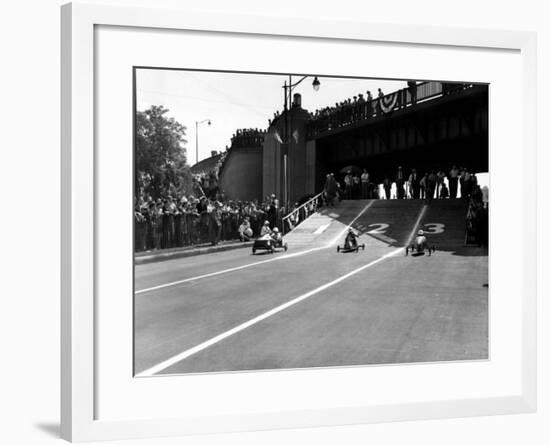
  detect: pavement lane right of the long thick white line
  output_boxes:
[157,248,488,374]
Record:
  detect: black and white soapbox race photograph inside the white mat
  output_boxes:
[133,67,490,377]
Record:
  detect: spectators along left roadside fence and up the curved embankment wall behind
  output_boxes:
[134,128,294,252]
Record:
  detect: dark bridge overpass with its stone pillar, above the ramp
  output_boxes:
[262,82,489,202]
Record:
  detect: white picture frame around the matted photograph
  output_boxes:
[61,3,537,442]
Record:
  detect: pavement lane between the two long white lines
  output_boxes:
[134,237,394,373]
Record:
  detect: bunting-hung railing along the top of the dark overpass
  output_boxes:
[307,81,473,138]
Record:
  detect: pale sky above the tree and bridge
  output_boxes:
[136,69,407,165]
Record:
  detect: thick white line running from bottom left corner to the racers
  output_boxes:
[136,247,403,377]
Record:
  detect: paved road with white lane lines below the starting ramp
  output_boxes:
[135,200,488,375]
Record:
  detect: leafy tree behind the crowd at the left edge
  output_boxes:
[135,105,192,199]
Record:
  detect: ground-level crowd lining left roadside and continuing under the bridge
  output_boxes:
[134,166,488,251]
